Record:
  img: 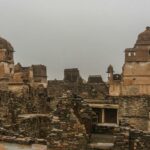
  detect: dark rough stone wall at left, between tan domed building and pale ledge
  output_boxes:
[0,86,50,125]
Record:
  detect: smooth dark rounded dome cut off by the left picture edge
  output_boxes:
[0,37,14,51]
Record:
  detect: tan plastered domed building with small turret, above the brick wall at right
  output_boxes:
[107,27,150,96]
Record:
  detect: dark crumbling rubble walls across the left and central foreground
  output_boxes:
[0,86,96,150]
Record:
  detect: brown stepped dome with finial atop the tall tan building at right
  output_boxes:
[135,27,150,46]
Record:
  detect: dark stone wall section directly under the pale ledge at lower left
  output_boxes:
[17,114,51,139]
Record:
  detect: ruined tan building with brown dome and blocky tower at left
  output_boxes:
[0,38,47,92]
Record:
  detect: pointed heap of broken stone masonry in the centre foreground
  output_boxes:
[48,95,87,150]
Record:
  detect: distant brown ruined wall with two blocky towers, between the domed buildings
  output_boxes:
[47,68,108,99]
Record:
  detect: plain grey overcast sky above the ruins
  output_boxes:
[0,0,150,79]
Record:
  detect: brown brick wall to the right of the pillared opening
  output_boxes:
[118,96,150,130]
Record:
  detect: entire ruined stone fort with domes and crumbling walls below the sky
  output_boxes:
[0,27,150,150]
